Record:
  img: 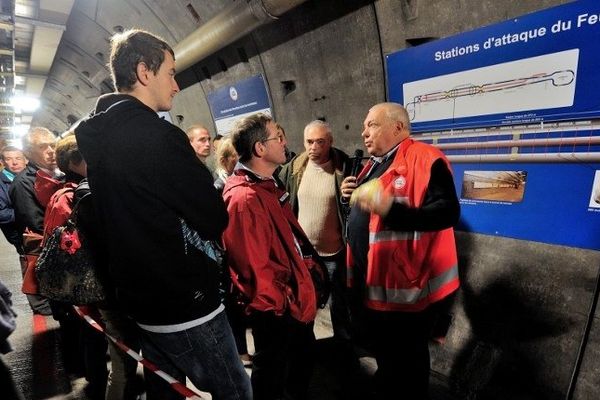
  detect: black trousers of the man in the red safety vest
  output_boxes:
[367,307,437,400]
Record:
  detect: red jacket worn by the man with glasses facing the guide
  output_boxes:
[223,169,317,323]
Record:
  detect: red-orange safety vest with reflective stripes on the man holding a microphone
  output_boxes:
[348,138,459,312]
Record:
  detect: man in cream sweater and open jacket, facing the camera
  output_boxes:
[279,120,351,340]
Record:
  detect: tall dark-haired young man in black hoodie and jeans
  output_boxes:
[75,29,252,400]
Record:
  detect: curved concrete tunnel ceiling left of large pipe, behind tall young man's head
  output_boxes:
[0,0,221,138]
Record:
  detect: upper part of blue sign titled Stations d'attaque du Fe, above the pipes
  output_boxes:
[386,0,600,132]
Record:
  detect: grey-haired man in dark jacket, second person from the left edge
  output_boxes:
[9,127,56,315]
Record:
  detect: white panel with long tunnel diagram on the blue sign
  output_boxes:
[402,49,579,122]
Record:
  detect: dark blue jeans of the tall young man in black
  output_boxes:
[140,312,252,400]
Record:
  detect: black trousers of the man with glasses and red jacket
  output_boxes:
[250,312,315,400]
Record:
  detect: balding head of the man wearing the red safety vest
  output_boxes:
[361,103,410,157]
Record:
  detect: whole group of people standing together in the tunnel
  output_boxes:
[0,30,460,400]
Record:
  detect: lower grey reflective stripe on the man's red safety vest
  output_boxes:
[367,265,458,304]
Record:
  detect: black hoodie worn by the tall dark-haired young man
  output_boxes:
[75,94,228,325]
